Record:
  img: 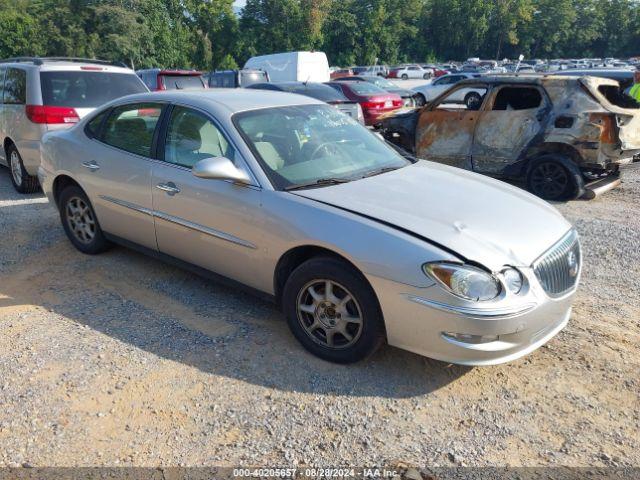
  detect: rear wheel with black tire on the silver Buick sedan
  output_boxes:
[58,186,110,255]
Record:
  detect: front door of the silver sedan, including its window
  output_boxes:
[152,106,261,287]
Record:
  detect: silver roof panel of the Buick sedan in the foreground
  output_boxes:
[109,88,324,115]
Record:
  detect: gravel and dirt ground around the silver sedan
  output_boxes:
[0,165,640,466]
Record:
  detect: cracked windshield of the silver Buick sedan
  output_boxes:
[234,105,410,190]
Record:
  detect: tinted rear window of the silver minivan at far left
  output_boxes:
[40,71,147,108]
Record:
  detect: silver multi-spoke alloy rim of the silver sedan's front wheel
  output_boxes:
[297,279,363,350]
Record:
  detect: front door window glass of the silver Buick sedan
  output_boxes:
[164,107,235,168]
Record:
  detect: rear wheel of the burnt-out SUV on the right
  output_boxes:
[527,155,584,201]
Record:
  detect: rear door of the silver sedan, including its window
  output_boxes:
[77,103,164,250]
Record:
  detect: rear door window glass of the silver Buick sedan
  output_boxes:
[102,103,162,157]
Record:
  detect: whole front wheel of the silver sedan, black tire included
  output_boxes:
[282,257,385,363]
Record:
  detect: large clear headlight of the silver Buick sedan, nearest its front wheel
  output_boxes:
[422,262,501,302]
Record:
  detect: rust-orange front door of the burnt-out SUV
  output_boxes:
[416,86,487,170]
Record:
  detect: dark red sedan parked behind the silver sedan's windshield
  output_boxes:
[327,81,403,125]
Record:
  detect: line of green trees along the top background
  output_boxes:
[0,0,640,70]
